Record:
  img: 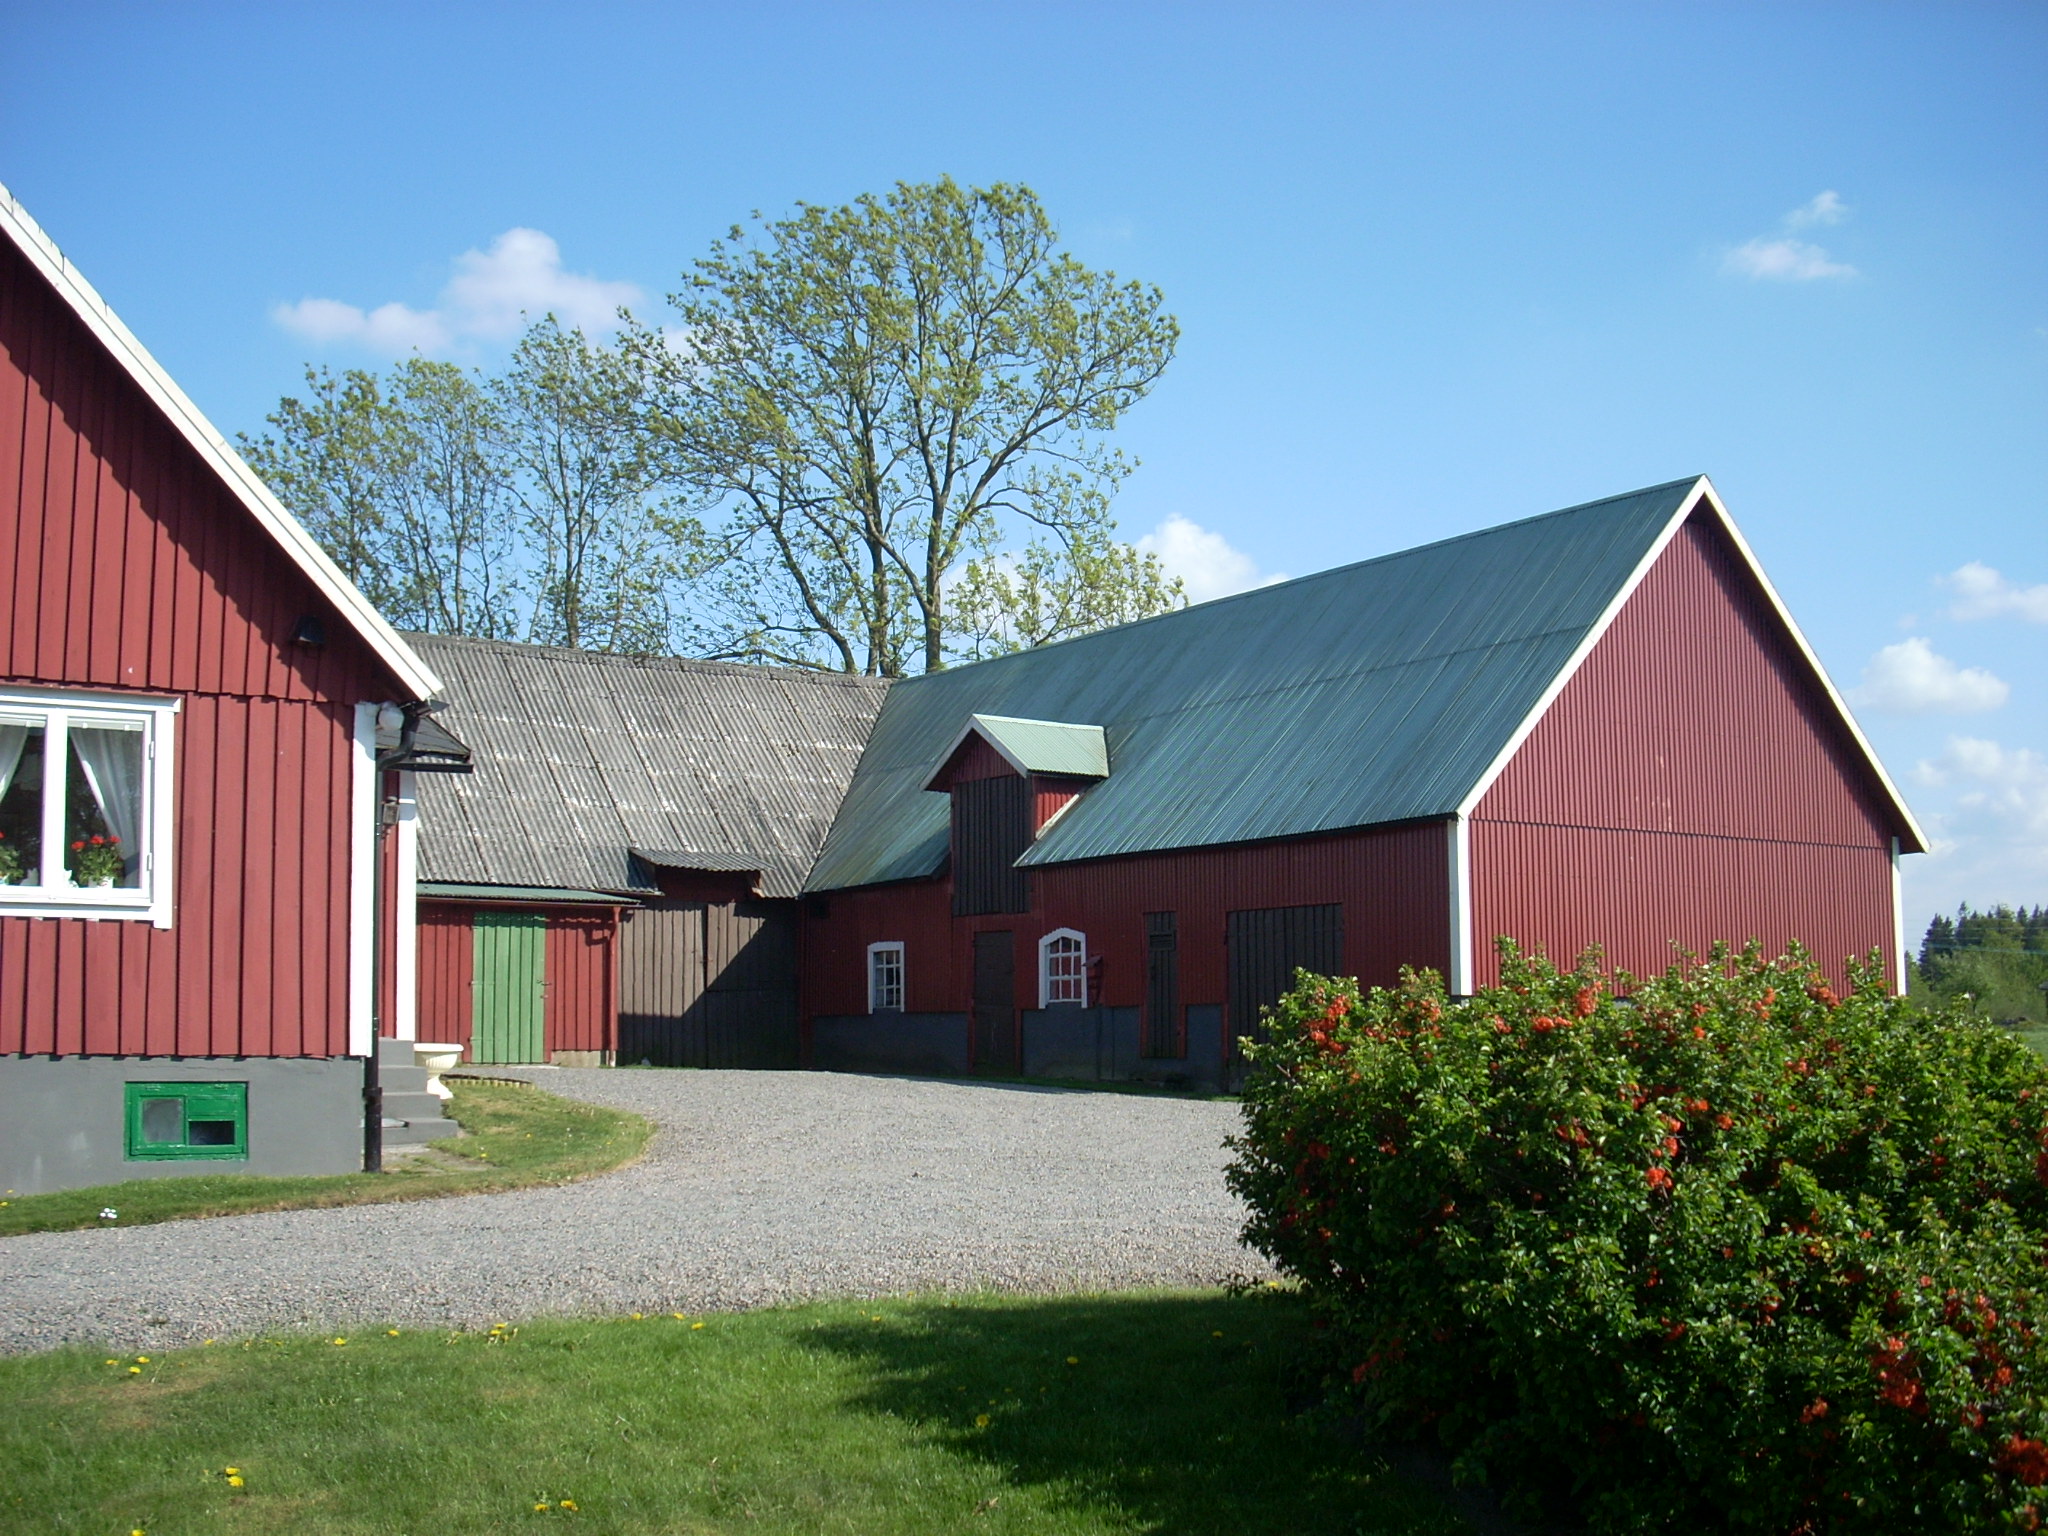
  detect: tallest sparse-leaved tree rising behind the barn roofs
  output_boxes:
[625,178,1180,676]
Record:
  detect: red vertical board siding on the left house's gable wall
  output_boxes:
[0,228,395,1057]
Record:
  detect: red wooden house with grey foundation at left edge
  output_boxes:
[0,188,451,1192]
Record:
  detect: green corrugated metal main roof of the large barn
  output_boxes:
[809,477,1700,891]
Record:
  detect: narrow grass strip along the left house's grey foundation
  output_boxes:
[0,1081,653,1237]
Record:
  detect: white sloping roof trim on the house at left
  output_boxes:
[0,184,440,698]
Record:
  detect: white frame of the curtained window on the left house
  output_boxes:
[0,688,184,928]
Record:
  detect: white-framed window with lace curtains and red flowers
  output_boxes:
[0,688,178,928]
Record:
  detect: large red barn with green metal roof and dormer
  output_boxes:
[803,479,1923,1081]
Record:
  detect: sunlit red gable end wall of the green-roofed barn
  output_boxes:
[1470,514,1896,985]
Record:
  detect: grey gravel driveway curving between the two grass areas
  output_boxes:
[0,1071,1266,1354]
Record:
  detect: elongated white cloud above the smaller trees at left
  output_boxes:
[270,229,641,356]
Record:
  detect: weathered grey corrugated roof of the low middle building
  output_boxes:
[408,635,887,897]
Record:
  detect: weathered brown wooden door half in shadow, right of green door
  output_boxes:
[618,901,797,1067]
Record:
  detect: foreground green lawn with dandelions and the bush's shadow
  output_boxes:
[0,1292,1462,1536]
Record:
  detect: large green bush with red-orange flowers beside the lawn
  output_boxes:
[1229,946,2048,1532]
